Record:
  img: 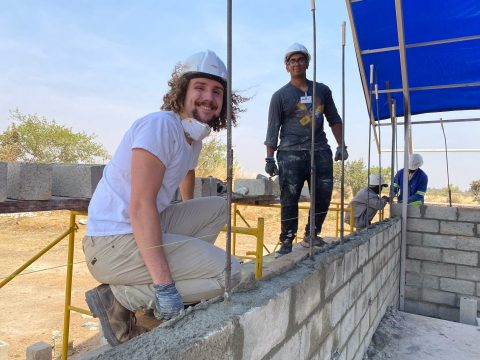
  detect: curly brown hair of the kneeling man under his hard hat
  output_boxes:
[160,63,250,132]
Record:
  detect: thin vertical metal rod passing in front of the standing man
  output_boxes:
[309,0,317,259]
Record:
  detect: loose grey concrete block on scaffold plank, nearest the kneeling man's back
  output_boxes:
[52,164,105,198]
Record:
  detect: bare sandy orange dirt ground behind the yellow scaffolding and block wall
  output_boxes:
[0,201,352,359]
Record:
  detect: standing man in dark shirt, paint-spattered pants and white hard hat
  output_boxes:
[265,43,348,256]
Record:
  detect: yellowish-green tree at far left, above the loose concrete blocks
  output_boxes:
[0,109,110,163]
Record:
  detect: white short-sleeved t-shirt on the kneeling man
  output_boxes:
[86,111,202,236]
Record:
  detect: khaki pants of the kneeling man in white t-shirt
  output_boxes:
[83,196,241,311]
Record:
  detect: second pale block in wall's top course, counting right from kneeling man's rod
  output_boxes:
[293,271,323,324]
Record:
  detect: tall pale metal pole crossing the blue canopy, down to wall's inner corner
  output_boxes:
[395,0,411,311]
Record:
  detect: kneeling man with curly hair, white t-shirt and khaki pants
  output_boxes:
[83,50,241,346]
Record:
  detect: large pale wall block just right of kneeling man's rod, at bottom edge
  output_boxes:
[239,290,291,359]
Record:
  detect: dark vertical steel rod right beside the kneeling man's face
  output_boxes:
[224,0,233,301]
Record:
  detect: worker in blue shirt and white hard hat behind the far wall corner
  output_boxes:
[393,153,428,205]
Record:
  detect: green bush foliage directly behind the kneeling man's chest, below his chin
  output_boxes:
[195,136,240,180]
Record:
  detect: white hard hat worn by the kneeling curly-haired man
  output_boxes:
[182,50,227,86]
